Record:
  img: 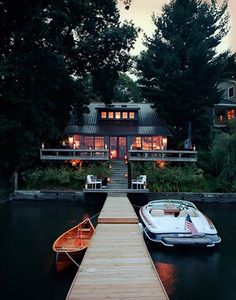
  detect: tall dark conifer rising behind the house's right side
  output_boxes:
[138,0,229,145]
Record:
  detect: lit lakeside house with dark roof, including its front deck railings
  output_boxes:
[40,102,197,164]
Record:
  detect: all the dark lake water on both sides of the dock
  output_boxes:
[0,199,236,300]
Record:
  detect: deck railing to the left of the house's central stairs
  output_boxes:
[40,149,109,160]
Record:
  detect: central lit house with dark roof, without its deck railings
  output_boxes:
[61,103,171,159]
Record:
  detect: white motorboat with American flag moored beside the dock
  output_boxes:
[139,199,221,247]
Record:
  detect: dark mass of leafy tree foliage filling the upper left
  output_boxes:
[0,0,138,177]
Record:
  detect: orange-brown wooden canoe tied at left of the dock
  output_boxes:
[52,218,94,272]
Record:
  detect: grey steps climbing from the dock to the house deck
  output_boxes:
[107,160,128,190]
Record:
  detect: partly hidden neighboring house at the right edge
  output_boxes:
[213,80,236,128]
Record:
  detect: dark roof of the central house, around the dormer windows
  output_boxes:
[64,103,171,136]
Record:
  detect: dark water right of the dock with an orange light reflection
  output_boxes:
[148,205,236,300]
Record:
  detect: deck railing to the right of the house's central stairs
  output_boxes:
[128,150,197,162]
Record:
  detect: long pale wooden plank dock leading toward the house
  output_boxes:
[66,196,168,300]
